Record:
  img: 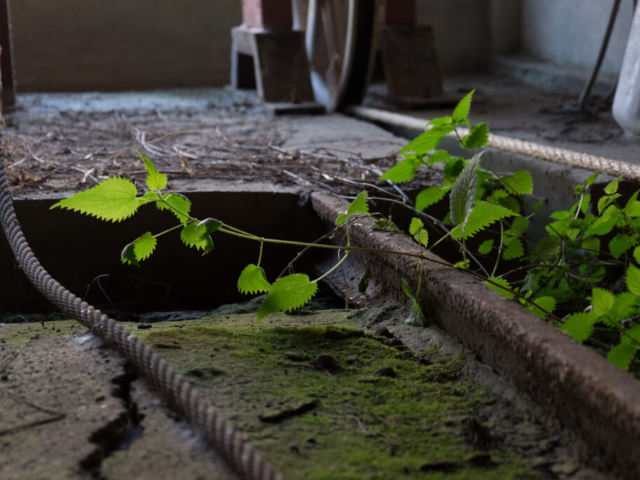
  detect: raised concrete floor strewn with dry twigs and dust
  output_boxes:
[4,90,416,195]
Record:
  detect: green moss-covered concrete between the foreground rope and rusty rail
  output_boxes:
[136,312,536,480]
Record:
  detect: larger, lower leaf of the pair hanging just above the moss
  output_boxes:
[258,273,318,320]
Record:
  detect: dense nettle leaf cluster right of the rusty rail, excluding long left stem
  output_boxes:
[381,92,640,369]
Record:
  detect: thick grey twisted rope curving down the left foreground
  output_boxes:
[0,123,283,480]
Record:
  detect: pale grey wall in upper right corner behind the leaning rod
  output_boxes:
[521,0,632,75]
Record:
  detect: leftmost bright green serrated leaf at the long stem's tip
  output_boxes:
[51,177,146,222]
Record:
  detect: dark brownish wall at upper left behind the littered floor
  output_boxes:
[11,0,242,92]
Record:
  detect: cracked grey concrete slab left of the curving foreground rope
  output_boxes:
[0,322,237,480]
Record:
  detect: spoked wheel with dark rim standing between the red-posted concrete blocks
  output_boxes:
[294,0,378,111]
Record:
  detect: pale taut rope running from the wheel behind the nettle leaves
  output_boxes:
[349,107,640,180]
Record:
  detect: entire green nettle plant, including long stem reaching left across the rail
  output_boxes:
[52,91,640,369]
